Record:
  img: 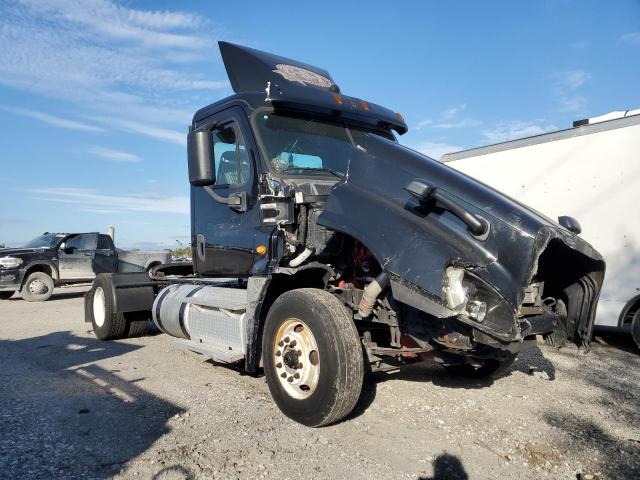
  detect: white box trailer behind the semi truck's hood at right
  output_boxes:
[440,110,640,347]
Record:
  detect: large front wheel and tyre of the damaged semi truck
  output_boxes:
[262,288,364,427]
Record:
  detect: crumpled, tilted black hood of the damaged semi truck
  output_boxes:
[318,134,605,347]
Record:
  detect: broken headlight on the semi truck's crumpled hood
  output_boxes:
[442,267,513,328]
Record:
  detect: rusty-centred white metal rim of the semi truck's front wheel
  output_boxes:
[273,318,320,400]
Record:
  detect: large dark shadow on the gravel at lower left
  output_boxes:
[0,332,184,478]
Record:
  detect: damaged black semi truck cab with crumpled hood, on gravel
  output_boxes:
[85,42,605,426]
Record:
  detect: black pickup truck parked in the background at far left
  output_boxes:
[0,232,171,302]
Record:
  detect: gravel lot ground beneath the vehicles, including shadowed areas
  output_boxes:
[0,287,640,480]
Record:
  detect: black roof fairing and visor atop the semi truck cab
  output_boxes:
[198,42,408,135]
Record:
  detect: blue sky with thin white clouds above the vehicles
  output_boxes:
[0,0,640,247]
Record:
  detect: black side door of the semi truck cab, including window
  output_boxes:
[191,107,260,277]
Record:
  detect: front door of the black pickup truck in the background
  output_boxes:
[58,233,98,281]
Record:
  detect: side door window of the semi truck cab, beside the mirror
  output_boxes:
[213,122,251,186]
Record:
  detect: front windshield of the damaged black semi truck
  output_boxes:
[256,113,391,177]
